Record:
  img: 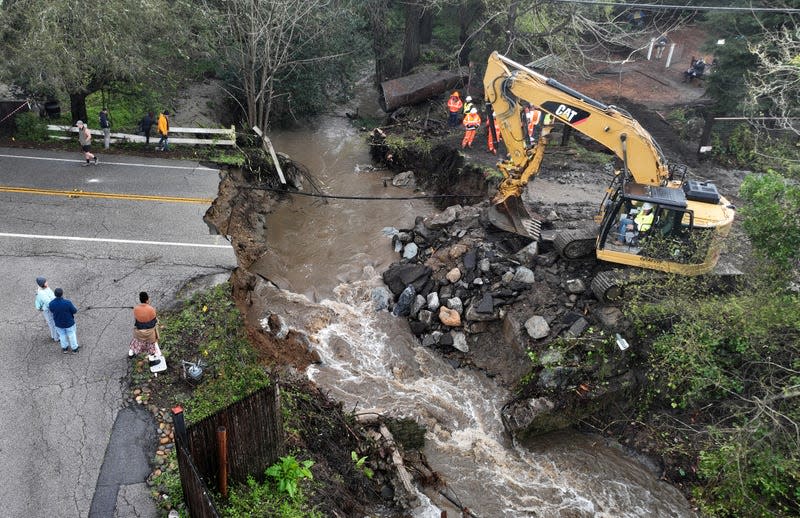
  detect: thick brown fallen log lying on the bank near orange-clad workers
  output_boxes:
[378,70,466,113]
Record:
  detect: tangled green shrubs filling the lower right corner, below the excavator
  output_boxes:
[626,267,800,517]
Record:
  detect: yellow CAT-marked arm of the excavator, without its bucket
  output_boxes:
[484,52,670,204]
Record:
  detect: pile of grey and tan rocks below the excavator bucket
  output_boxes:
[373,205,552,352]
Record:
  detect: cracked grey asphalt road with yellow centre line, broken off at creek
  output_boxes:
[0,148,235,518]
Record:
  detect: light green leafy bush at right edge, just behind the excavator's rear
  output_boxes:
[739,172,800,266]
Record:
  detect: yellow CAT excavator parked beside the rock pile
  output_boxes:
[484,52,735,301]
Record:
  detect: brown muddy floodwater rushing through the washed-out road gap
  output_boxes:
[251,91,693,518]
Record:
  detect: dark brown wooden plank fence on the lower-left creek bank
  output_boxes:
[173,383,285,517]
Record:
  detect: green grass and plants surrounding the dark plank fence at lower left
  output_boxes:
[141,283,383,518]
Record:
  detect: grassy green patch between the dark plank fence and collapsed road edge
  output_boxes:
[161,283,271,422]
